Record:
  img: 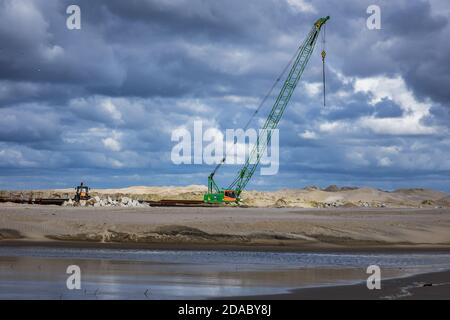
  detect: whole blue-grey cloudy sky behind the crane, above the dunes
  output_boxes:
[0,0,450,191]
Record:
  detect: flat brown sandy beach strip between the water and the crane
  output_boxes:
[0,204,450,250]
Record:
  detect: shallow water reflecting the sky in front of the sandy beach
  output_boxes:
[0,247,450,299]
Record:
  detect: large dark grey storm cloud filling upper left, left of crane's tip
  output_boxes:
[0,1,310,100]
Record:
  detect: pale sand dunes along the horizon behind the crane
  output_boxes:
[0,185,450,208]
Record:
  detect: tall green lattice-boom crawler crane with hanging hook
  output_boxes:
[203,16,330,203]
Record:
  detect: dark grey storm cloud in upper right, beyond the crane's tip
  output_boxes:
[320,1,450,105]
